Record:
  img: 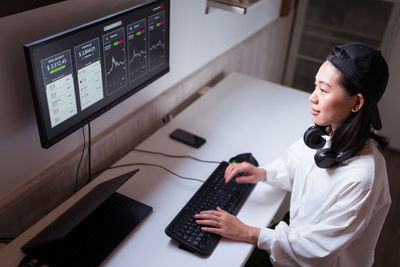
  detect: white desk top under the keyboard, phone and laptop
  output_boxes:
[0,73,312,267]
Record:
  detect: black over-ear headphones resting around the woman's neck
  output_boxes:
[303,125,357,169]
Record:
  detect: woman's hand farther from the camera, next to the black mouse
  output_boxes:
[225,162,267,184]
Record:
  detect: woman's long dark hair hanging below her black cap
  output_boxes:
[331,70,389,153]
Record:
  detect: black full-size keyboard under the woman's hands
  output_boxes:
[165,161,255,256]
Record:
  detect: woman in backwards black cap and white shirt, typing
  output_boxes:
[195,43,391,267]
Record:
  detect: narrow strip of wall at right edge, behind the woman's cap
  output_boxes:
[379,24,400,150]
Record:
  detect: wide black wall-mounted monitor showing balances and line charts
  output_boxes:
[24,0,169,148]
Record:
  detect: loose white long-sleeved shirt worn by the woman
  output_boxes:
[257,138,391,267]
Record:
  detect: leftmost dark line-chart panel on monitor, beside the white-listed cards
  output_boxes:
[103,28,126,94]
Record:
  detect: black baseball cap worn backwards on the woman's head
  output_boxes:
[326,43,389,130]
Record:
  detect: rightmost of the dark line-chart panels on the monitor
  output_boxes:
[148,11,166,70]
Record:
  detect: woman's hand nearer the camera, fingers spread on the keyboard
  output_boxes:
[194,207,260,244]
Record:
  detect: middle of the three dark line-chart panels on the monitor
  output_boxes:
[127,19,147,81]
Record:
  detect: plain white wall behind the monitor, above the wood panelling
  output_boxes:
[0,0,281,197]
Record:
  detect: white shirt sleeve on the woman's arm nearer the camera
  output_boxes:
[257,182,373,266]
